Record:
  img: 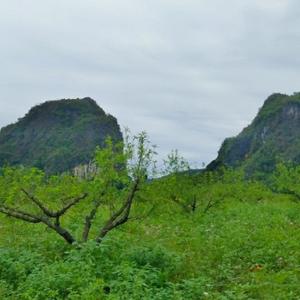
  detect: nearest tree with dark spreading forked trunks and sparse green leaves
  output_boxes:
[0,132,155,244]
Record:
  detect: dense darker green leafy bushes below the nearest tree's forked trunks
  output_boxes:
[0,242,185,299]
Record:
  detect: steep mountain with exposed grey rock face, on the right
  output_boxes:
[207,93,300,173]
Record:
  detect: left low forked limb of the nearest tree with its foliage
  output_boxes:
[0,167,87,244]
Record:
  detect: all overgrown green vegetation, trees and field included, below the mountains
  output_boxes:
[0,133,300,300]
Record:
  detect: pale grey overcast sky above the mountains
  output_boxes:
[0,0,300,164]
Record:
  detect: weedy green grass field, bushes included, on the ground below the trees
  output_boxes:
[0,191,300,299]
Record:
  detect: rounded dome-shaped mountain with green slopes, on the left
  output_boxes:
[0,98,122,173]
